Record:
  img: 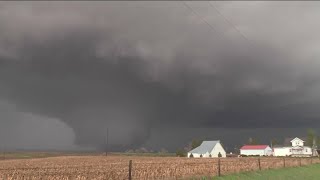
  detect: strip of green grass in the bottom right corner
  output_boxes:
[211,164,320,180]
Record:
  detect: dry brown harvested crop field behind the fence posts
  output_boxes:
[0,156,320,180]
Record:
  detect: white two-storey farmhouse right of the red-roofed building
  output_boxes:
[273,137,312,157]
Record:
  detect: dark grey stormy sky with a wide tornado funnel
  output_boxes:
[0,1,320,149]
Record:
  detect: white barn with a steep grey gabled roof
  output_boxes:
[188,140,226,158]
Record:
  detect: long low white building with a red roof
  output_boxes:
[240,145,272,156]
